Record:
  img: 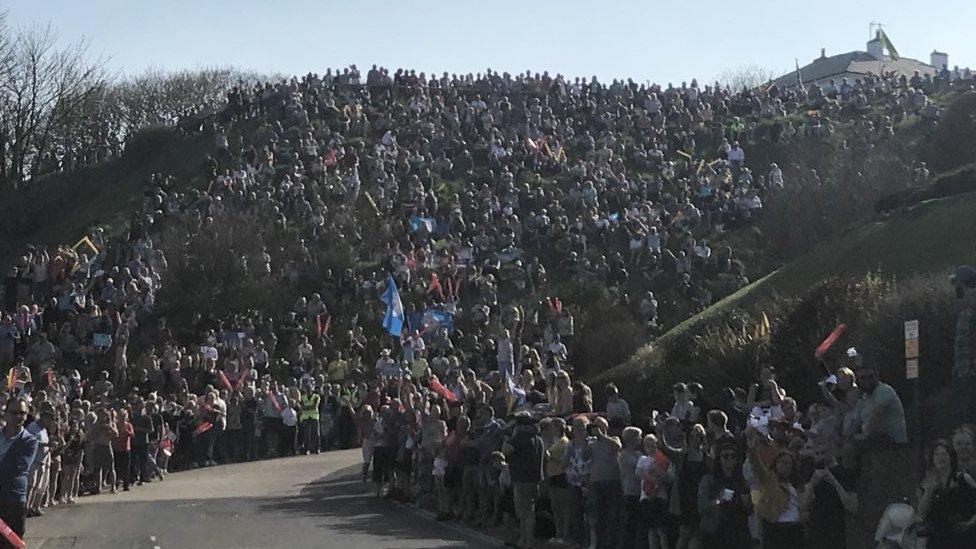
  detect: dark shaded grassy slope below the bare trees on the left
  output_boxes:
[0,128,212,266]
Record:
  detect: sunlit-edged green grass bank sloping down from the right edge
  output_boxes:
[601,187,976,379]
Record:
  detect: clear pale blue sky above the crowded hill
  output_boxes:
[7,0,976,83]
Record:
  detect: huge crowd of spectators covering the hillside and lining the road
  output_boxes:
[0,62,976,548]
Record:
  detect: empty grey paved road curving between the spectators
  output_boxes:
[27,450,492,549]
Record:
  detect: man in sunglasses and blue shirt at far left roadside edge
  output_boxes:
[0,398,37,538]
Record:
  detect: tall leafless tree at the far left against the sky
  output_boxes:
[0,24,106,186]
